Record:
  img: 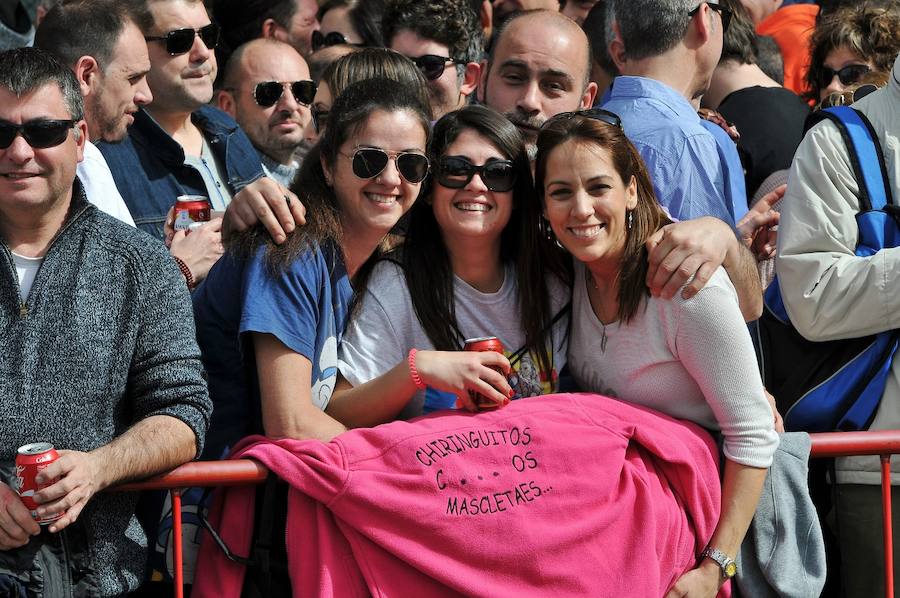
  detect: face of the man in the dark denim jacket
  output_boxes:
[147,0,216,113]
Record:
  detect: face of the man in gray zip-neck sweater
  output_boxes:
[0,83,87,221]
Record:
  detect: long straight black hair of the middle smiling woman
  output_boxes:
[401,106,569,370]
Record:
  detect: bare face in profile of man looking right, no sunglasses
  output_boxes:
[84,21,153,143]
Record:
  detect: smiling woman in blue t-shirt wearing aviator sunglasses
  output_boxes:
[194,79,430,458]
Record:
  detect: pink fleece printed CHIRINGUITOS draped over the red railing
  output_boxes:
[193,394,720,598]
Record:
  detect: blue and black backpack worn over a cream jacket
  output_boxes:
[759,106,900,432]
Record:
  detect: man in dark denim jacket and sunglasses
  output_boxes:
[99,0,263,238]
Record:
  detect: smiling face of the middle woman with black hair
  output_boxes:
[431,129,513,246]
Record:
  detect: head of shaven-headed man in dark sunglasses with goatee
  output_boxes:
[217,38,316,187]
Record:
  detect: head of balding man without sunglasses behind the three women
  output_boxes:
[478,5,597,158]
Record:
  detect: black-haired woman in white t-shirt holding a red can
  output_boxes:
[328,106,569,426]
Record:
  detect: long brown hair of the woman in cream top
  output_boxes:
[534,115,671,323]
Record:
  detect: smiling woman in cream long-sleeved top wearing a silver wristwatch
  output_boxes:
[535,110,778,596]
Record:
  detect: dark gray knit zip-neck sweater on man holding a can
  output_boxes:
[0,184,212,596]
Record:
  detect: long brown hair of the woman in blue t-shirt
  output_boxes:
[227,78,430,275]
